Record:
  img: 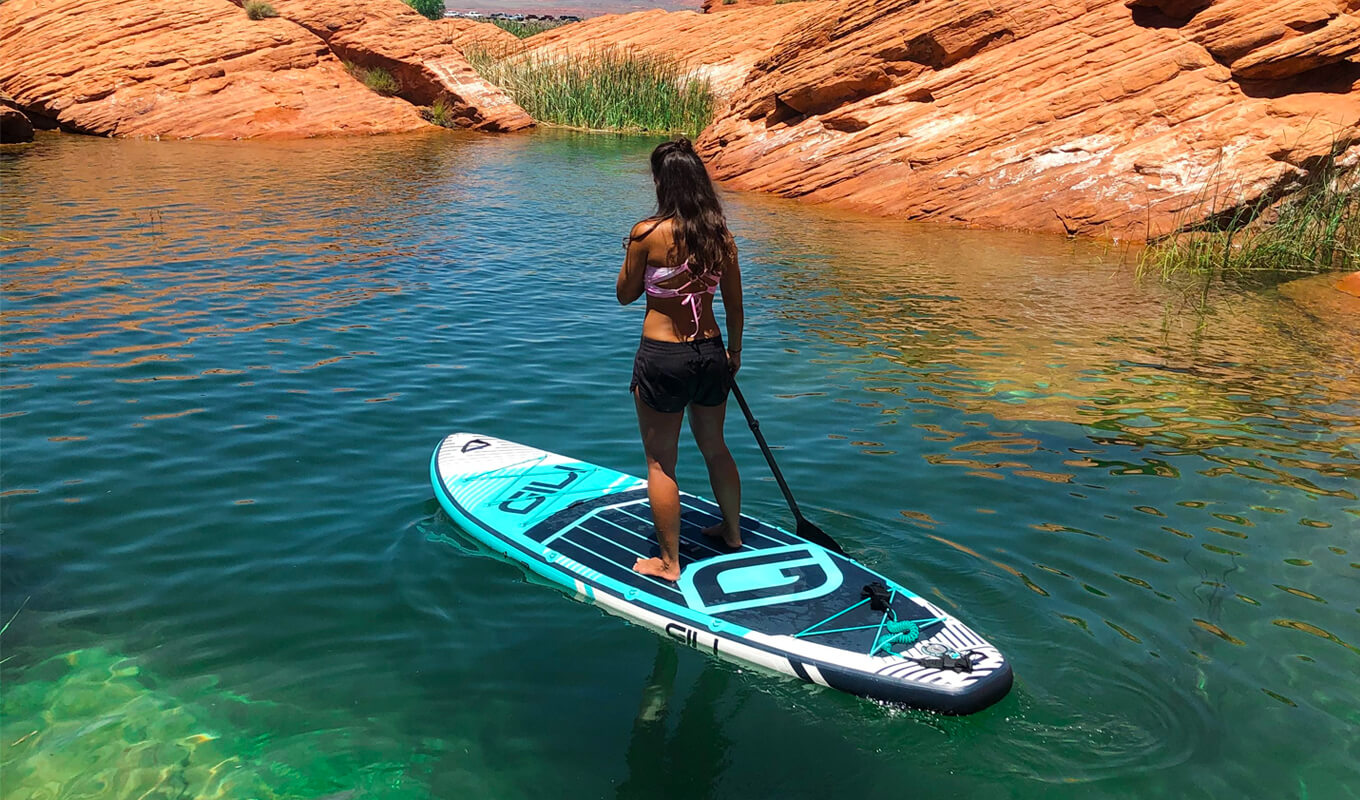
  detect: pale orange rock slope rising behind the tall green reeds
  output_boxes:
[524,3,823,97]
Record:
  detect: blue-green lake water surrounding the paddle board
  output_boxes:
[0,132,1360,800]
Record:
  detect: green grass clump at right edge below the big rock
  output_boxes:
[1138,158,1360,283]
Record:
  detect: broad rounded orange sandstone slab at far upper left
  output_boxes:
[0,0,428,139]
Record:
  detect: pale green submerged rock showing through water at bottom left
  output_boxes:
[0,648,431,800]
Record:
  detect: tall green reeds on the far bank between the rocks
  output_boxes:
[464,48,714,135]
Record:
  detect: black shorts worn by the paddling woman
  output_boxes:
[628,336,732,414]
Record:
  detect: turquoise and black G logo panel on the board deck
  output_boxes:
[680,544,845,614]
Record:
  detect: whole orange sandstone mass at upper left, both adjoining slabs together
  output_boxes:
[0,0,533,139]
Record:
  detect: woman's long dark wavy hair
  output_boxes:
[651,137,732,273]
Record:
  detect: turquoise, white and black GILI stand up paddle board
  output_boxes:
[430,433,1012,714]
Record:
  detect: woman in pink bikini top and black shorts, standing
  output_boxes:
[616,139,743,581]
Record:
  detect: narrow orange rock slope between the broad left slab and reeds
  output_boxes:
[247,0,533,131]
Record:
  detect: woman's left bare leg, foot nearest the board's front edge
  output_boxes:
[632,392,684,581]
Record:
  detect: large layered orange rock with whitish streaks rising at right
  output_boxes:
[696,0,1360,238]
